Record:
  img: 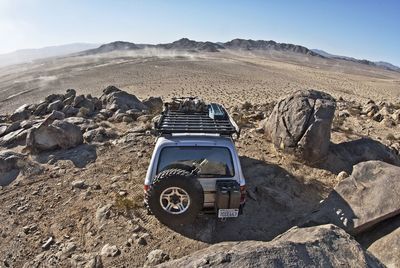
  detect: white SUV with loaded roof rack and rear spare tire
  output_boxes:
[144,98,246,225]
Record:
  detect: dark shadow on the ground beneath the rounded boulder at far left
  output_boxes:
[35,144,97,168]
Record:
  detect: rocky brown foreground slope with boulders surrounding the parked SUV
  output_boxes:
[0,86,400,267]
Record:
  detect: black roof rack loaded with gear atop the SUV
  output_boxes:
[155,97,240,138]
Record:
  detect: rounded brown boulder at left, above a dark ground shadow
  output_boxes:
[26,118,83,152]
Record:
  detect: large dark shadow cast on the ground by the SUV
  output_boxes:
[169,157,321,243]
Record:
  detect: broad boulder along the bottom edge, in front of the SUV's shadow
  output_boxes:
[159,225,384,267]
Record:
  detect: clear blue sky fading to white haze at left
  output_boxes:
[0,0,400,65]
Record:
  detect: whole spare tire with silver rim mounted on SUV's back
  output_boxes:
[145,169,204,225]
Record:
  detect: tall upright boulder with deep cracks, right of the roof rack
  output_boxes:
[264,90,336,163]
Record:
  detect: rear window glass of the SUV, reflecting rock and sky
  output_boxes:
[157,146,234,178]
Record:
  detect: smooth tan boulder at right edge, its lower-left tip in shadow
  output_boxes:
[304,161,400,234]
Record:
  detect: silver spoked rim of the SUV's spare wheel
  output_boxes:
[160,187,190,214]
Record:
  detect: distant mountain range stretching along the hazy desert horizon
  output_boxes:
[0,38,400,72]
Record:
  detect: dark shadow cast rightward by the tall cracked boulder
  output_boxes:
[319,138,400,174]
